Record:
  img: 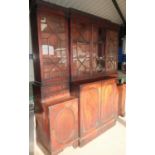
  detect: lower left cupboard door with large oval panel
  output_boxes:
[49,99,78,153]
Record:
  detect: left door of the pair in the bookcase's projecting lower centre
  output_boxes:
[80,82,101,136]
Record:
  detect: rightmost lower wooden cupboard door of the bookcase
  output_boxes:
[101,81,116,123]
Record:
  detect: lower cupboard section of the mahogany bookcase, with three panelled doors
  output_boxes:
[36,79,118,155]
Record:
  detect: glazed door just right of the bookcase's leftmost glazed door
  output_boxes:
[71,17,92,81]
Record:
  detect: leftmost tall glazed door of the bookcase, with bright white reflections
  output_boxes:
[37,8,69,92]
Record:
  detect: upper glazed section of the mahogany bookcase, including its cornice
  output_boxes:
[30,1,119,84]
